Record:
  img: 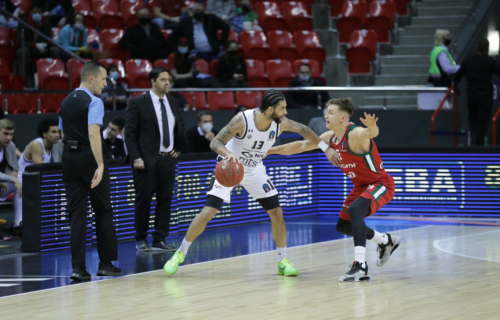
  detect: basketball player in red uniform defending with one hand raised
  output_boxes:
[268,98,401,282]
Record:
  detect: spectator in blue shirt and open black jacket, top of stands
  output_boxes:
[169,3,229,62]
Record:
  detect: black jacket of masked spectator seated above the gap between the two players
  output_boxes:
[285,77,330,108]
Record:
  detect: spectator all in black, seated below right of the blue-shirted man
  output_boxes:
[217,40,248,88]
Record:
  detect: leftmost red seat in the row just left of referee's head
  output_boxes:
[36,58,69,90]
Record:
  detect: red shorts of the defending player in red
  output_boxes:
[339,181,394,221]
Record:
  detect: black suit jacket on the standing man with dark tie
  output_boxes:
[125,91,187,169]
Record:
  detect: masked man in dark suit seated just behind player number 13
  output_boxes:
[186,111,219,153]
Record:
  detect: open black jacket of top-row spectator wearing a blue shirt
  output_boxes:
[168,14,230,53]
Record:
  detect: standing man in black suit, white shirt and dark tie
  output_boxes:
[125,67,187,252]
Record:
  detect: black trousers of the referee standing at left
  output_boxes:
[62,144,118,269]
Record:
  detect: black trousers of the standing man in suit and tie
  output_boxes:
[132,154,177,241]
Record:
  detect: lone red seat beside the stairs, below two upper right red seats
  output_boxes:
[345,30,377,74]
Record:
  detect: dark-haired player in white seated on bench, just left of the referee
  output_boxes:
[11,118,63,236]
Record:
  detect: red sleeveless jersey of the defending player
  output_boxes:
[330,123,394,186]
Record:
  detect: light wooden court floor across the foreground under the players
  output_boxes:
[0,225,500,320]
